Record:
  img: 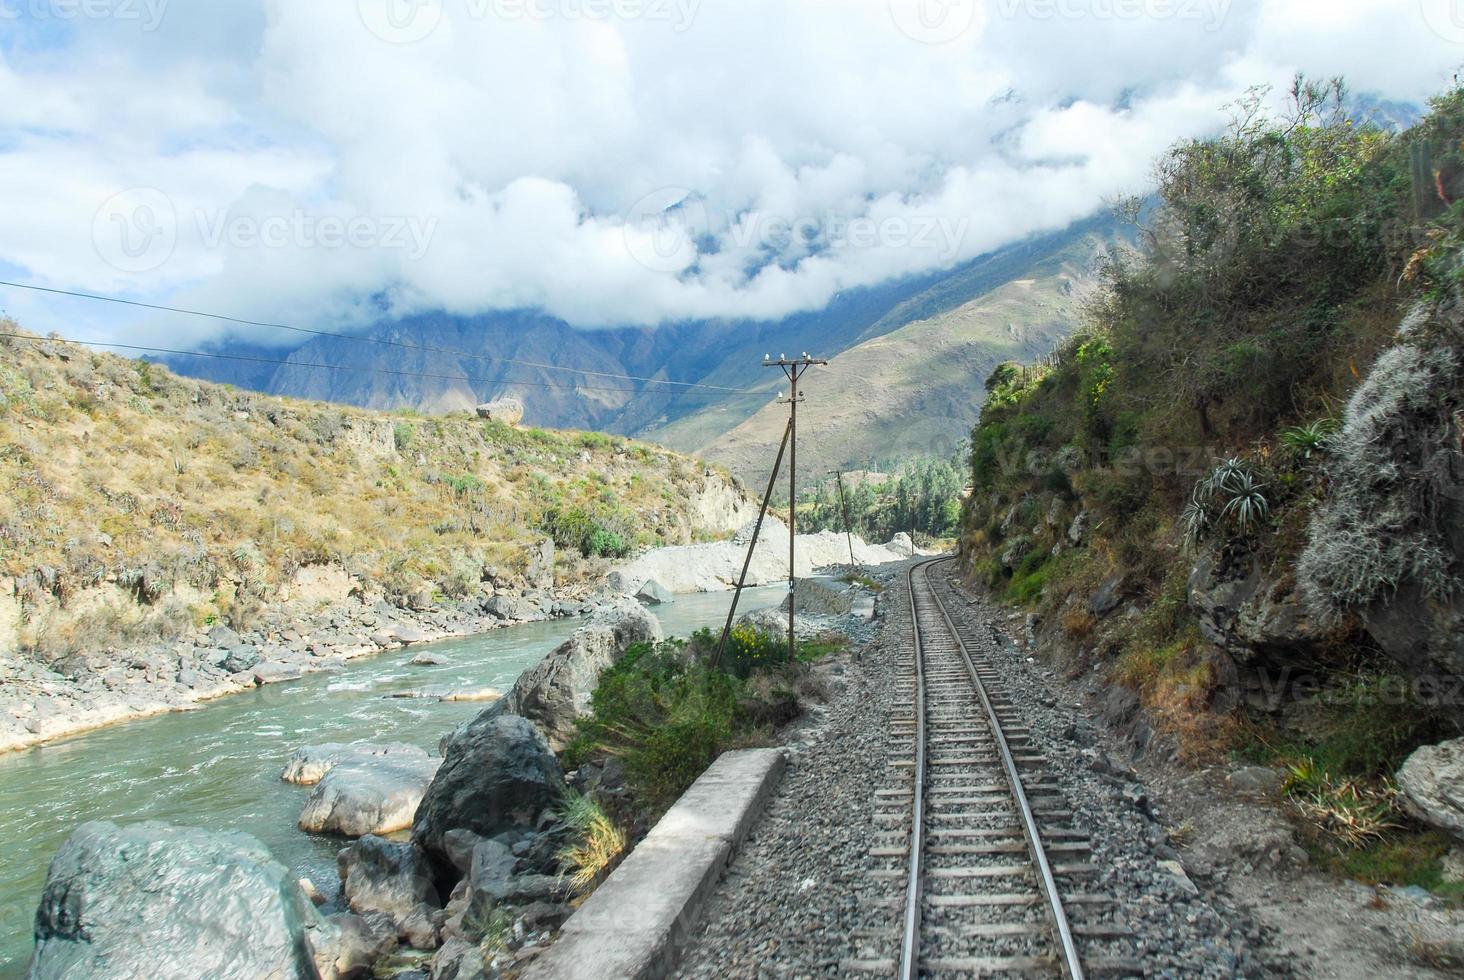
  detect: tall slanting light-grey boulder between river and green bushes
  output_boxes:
[486,598,663,751]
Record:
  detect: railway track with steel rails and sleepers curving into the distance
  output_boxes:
[843,560,1142,980]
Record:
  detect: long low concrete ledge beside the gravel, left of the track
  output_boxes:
[523,749,788,980]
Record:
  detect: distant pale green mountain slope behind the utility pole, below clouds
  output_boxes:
[696,224,1113,483]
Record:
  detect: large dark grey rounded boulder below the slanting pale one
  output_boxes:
[411,714,565,876]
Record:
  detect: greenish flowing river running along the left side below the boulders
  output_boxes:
[0,586,788,977]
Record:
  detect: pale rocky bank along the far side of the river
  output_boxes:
[0,514,911,753]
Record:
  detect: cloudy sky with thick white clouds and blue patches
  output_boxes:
[0,0,1464,346]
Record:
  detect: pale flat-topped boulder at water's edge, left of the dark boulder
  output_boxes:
[300,757,442,836]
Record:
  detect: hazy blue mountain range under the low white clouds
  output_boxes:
[160,218,1114,461]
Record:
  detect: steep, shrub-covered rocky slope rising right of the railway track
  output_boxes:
[962,82,1464,886]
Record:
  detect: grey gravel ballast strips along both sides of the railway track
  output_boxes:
[676,565,1285,977]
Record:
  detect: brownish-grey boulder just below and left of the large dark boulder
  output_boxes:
[337,836,442,949]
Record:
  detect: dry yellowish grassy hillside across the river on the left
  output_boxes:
[0,328,736,653]
